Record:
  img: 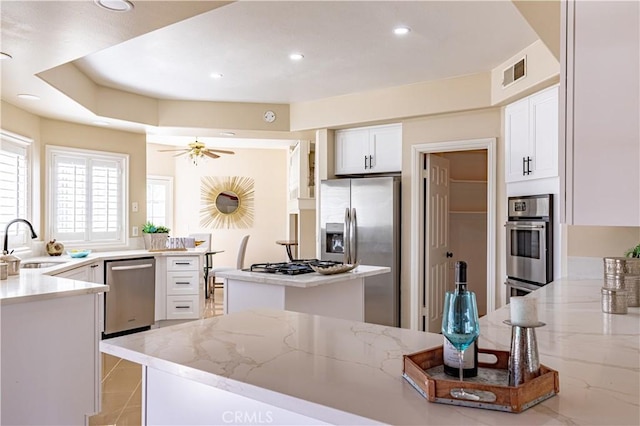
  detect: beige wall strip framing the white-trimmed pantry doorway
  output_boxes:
[401,107,506,327]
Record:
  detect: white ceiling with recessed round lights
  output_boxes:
[0,0,537,145]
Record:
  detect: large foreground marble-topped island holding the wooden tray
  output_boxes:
[101,280,640,425]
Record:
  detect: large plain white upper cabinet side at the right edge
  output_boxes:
[561,1,640,226]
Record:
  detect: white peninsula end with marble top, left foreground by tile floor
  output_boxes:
[0,269,109,425]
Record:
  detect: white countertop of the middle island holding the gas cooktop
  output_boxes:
[216,265,391,288]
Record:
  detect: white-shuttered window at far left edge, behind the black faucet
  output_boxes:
[0,131,32,250]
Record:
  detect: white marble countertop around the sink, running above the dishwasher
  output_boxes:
[0,248,205,305]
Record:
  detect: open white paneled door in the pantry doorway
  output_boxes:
[423,154,452,333]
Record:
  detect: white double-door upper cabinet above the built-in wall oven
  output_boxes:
[505,86,558,182]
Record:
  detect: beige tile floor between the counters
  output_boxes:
[89,288,223,426]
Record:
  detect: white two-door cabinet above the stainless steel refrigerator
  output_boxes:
[335,124,402,175]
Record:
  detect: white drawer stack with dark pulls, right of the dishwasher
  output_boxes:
[166,256,202,319]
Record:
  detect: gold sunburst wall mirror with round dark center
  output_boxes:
[200,176,253,228]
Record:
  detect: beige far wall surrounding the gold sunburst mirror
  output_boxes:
[146,145,288,266]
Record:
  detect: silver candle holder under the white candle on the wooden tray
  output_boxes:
[504,320,545,387]
